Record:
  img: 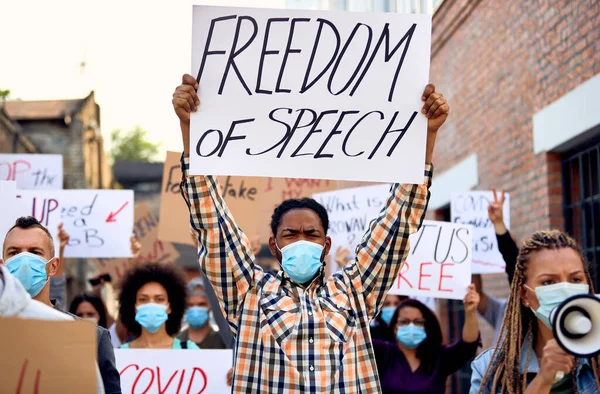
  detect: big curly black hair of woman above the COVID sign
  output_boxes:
[119,263,187,337]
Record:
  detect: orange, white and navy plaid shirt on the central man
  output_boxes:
[181,157,432,394]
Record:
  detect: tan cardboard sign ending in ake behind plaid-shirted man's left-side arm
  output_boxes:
[158,152,266,245]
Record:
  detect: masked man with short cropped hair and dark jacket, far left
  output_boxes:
[0,216,121,394]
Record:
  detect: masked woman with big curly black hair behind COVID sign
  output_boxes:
[119,263,199,349]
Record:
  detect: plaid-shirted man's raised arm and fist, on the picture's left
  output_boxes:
[173,74,260,333]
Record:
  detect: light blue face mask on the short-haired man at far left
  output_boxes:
[5,252,52,297]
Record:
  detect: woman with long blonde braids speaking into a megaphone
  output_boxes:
[470,230,600,394]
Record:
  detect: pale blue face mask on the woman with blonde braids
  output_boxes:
[524,282,590,329]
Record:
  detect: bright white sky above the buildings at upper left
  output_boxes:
[0,0,285,157]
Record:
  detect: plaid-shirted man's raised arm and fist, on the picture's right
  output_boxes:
[345,85,450,318]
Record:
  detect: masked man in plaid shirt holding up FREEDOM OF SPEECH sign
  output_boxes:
[173,67,449,393]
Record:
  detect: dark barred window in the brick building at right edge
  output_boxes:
[562,141,600,292]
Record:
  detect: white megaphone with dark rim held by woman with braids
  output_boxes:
[550,294,600,357]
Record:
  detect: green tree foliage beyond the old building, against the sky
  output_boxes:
[110,126,160,162]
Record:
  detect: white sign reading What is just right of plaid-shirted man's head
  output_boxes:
[313,185,390,257]
